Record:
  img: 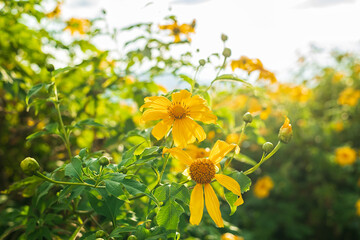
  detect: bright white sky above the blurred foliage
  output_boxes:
[62,0,360,80]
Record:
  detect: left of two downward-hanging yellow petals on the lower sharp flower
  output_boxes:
[190,184,204,225]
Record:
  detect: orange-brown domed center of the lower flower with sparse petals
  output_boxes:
[189,158,215,184]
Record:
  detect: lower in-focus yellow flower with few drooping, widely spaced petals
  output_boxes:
[163,140,244,227]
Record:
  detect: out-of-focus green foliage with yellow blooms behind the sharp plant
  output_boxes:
[0,0,360,240]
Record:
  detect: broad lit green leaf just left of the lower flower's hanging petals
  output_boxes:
[156,201,184,230]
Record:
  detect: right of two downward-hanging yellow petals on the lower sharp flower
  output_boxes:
[204,183,224,227]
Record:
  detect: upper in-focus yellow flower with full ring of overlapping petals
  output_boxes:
[140,90,216,148]
